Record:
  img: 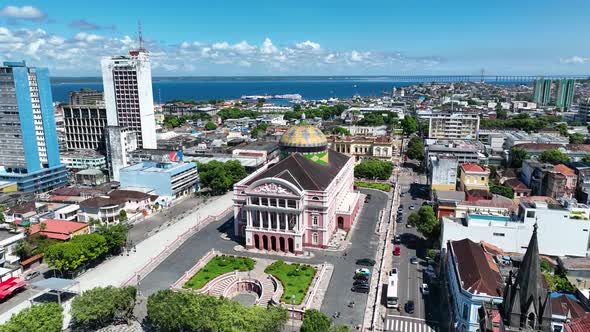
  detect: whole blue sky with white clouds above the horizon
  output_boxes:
[0,0,590,76]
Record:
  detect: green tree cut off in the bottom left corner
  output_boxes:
[0,302,63,332]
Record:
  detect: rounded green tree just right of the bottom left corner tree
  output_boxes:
[71,286,137,331]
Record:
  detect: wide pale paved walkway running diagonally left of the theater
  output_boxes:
[0,191,233,323]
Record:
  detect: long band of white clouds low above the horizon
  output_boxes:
[0,27,446,76]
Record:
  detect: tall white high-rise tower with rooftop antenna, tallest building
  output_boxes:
[101,45,157,149]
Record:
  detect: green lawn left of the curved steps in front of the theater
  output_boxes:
[182,255,256,289]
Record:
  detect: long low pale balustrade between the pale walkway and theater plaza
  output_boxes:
[122,207,233,286]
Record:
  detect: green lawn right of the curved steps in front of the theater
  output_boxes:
[264,261,316,304]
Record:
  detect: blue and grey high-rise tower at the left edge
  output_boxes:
[0,61,67,192]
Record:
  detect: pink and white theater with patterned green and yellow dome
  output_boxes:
[233,125,362,254]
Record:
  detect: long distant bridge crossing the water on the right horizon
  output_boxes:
[387,75,590,83]
